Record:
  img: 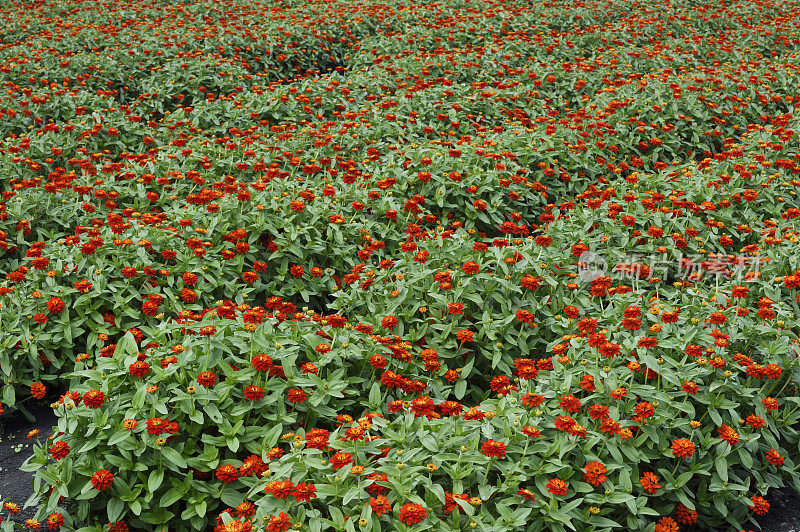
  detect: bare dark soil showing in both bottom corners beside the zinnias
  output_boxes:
[0,404,800,532]
